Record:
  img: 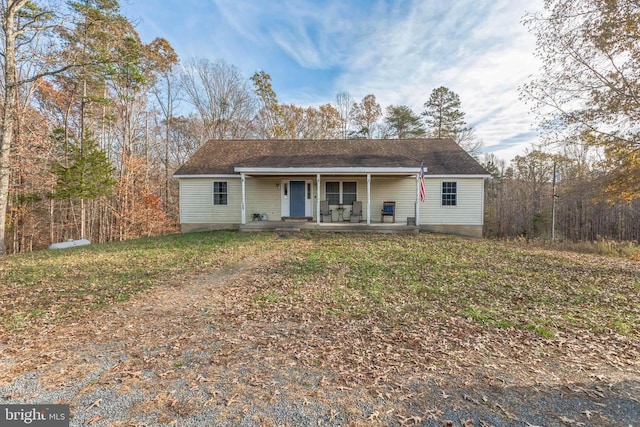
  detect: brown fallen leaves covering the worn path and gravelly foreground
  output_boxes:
[0,236,640,425]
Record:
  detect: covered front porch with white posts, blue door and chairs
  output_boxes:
[236,168,420,227]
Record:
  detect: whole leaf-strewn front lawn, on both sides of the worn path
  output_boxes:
[0,231,640,338]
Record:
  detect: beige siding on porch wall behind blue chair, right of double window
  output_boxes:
[365,176,416,223]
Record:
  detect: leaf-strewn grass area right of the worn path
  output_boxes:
[280,235,640,338]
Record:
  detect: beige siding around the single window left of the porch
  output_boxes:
[179,178,242,224]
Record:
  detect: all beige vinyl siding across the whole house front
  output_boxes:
[179,175,484,226]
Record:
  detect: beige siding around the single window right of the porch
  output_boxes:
[420,178,484,225]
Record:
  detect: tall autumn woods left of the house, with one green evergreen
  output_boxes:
[0,0,177,252]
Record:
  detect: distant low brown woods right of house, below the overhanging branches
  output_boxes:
[483,147,640,242]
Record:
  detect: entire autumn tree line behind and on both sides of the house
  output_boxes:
[0,0,638,253]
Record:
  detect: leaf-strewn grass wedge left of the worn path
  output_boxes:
[0,231,271,330]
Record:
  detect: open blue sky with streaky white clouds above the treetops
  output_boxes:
[121,0,542,160]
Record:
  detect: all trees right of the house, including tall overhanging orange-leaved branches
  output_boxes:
[487,0,640,242]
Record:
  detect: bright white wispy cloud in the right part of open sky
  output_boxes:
[330,0,537,157]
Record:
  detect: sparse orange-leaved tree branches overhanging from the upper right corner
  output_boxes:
[522,0,640,200]
